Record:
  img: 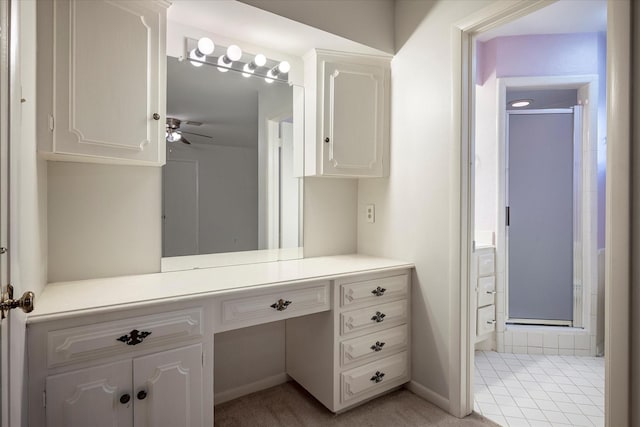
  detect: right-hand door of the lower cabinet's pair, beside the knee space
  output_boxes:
[133,344,204,427]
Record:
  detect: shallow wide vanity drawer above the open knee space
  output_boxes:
[216,282,331,332]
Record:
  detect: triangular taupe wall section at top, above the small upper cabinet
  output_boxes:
[240,0,394,53]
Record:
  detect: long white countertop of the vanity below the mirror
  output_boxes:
[27,254,413,323]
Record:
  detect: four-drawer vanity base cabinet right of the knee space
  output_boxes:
[286,270,411,412]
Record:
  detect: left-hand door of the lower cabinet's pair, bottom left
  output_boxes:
[46,360,133,427]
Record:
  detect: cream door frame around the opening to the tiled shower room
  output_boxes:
[449,0,631,425]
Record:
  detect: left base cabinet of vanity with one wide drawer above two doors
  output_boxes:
[29,308,213,427]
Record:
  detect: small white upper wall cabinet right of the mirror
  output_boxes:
[304,50,390,177]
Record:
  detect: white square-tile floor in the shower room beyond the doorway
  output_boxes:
[474,351,604,427]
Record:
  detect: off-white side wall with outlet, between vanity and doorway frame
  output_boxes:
[358,0,490,407]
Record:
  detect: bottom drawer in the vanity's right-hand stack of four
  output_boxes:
[340,351,409,403]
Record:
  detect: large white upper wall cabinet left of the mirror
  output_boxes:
[38,0,169,165]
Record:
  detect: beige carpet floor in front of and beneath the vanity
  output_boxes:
[214,381,497,427]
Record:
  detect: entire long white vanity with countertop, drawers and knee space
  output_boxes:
[27,255,413,426]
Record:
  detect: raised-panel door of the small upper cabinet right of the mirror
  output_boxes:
[321,61,387,177]
